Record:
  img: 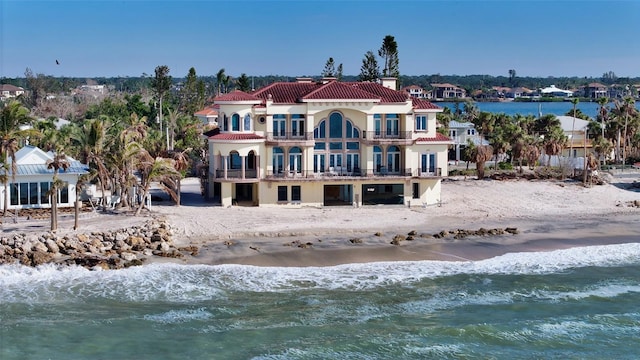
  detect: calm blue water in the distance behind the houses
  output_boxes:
[435,101,640,119]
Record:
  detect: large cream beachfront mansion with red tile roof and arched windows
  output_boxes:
[196,78,453,207]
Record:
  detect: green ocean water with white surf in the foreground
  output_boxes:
[0,243,640,360]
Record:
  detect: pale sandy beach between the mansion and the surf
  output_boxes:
[3,171,640,266]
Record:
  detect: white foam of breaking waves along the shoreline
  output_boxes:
[0,243,640,303]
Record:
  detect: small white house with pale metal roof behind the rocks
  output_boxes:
[0,145,88,209]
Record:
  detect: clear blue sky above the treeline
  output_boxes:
[0,0,640,77]
